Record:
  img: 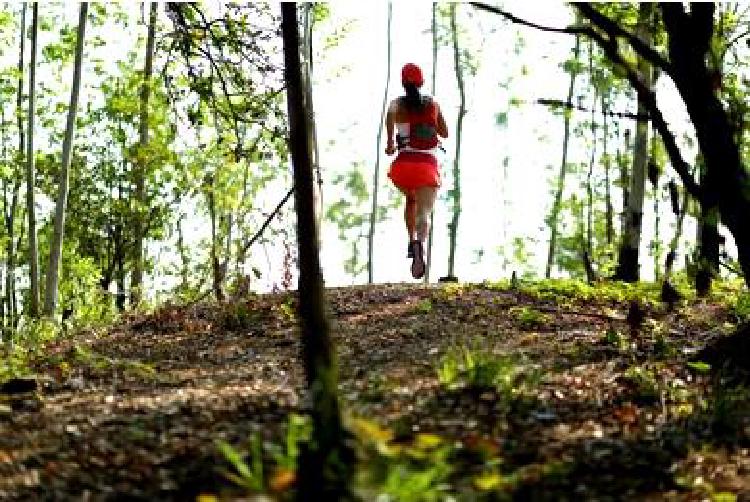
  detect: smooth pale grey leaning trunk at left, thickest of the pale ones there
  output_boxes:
[44,2,89,317]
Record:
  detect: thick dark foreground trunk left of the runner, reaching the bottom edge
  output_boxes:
[281,3,354,500]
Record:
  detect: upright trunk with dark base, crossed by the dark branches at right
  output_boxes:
[615,3,653,282]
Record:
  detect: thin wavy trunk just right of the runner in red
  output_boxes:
[448,3,466,279]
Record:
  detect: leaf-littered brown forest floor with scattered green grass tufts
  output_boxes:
[0,283,750,501]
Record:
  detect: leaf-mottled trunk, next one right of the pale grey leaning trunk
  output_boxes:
[130,2,157,306]
